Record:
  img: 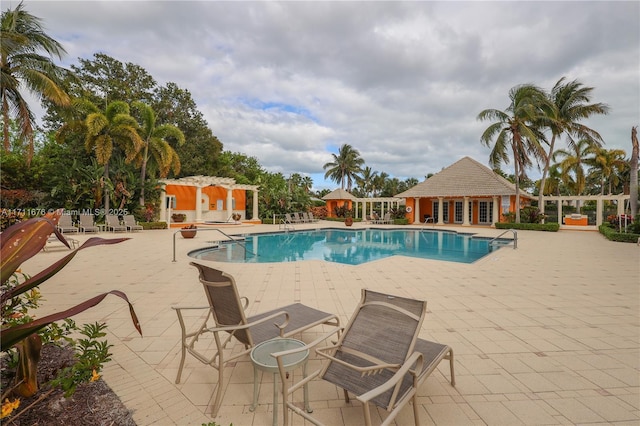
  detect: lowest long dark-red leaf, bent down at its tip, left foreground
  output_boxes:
[0,290,142,351]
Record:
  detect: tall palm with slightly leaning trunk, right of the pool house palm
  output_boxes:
[538,77,609,213]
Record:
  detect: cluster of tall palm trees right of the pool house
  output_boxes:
[477,77,629,222]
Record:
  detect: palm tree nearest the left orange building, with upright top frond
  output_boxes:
[132,101,184,206]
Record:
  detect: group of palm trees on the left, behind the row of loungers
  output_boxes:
[0,3,185,215]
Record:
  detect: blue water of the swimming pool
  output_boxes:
[189,229,509,265]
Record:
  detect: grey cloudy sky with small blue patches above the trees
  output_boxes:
[22,0,640,189]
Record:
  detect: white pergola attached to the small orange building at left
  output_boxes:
[160,175,259,222]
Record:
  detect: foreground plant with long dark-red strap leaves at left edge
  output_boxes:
[0,210,142,397]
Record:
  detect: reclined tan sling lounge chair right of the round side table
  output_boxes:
[273,290,455,426]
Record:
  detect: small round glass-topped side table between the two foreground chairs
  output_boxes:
[249,338,312,426]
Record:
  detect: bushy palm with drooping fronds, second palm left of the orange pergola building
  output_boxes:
[84,101,144,211]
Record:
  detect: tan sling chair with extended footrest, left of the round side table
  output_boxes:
[173,262,340,417]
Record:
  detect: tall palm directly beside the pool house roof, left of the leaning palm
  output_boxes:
[477,84,546,223]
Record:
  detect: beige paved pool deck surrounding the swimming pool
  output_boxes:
[22,222,640,426]
